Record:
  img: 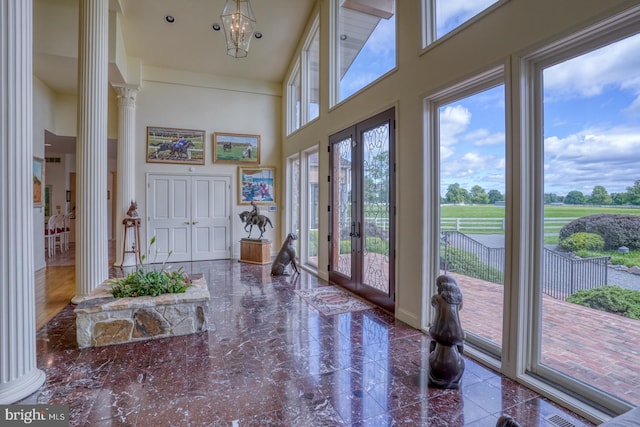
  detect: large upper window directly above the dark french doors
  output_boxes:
[331,0,396,105]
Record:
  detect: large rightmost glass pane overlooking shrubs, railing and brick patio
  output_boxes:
[539,35,640,405]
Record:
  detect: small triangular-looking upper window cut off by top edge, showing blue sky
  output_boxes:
[423,0,499,46]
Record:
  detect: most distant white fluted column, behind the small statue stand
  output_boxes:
[112,84,139,267]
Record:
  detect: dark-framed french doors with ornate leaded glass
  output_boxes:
[329,109,395,312]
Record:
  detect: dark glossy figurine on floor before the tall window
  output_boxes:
[429,275,464,389]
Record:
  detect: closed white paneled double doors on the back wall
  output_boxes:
[145,174,231,263]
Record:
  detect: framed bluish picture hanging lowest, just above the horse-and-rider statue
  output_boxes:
[238,166,276,205]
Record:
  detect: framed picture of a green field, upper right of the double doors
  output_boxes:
[213,132,260,164]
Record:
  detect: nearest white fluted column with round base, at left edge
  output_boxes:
[0,0,45,404]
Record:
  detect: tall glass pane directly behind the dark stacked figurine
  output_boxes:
[439,85,505,353]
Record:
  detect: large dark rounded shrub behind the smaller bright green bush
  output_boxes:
[559,214,640,250]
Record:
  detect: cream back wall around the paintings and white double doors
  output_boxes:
[136,67,284,257]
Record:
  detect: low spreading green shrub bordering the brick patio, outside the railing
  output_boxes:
[567,286,640,320]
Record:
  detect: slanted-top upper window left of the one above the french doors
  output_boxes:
[286,16,320,134]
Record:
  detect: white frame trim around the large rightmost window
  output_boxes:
[510,7,640,420]
